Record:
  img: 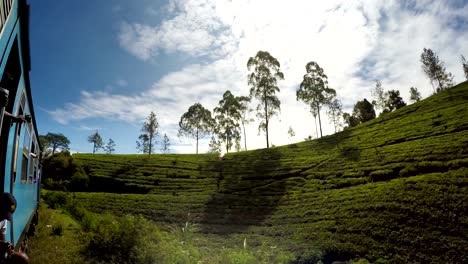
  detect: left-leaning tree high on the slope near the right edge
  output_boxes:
[421,48,453,92]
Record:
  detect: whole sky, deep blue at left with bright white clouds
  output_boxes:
[30,0,468,153]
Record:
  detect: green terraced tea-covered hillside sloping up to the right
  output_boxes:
[74,83,468,263]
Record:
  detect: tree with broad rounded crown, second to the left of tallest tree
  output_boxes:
[178,103,215,154]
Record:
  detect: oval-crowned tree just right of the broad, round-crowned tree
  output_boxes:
[214,90,242,153]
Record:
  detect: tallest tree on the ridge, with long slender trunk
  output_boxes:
[247,51,284,148]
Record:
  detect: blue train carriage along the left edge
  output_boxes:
[0,0,41,248]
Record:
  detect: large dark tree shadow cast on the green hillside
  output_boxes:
[200,148,288,235]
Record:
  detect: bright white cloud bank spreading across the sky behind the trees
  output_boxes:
[50,0,468,152]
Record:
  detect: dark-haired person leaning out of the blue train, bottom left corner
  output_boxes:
[0,192,29,264]
